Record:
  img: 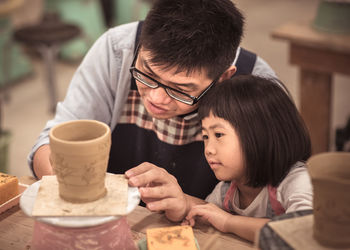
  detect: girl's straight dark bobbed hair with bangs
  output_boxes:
[198,75,311,187]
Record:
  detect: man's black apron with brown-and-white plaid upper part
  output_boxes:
[108,89,217,199]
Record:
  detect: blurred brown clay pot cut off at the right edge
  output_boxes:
[307,152,350,248]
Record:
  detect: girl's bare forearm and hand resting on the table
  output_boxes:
[184,203,269,242]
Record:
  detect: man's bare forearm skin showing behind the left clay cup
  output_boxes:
[33,144,53,179]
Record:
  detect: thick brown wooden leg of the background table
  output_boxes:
[300,69,332,154]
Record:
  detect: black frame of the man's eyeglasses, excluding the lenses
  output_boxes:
[129,45,220,106]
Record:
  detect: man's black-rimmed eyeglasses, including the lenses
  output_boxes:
[130,46,219,105]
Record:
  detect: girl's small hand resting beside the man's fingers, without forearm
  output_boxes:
[182,203,232,233]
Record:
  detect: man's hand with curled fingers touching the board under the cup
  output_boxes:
[125,162,190,221]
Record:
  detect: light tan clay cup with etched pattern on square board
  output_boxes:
[50,120,111,203]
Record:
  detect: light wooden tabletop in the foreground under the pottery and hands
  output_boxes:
[0,179,255,250]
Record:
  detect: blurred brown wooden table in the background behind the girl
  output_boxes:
[271,22,350,153]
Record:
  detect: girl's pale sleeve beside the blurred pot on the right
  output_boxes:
[277,165,313,213]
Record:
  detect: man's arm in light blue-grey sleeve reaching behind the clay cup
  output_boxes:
[28,23,137,178]
